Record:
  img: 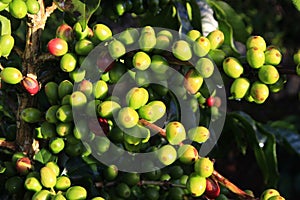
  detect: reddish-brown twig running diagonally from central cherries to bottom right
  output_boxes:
[139,119,255,199]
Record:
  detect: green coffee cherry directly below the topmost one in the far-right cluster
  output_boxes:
[246,47,265,69]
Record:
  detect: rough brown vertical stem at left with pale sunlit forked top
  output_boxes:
[16,0,56,156]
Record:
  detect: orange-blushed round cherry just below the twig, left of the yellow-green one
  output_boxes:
[177,144,199,165]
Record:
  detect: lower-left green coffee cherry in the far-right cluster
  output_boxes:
[230,77,250,99]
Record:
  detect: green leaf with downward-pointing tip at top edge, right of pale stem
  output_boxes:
[54,0,101,30]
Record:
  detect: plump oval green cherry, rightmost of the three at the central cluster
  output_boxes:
[138,101,166,123]
